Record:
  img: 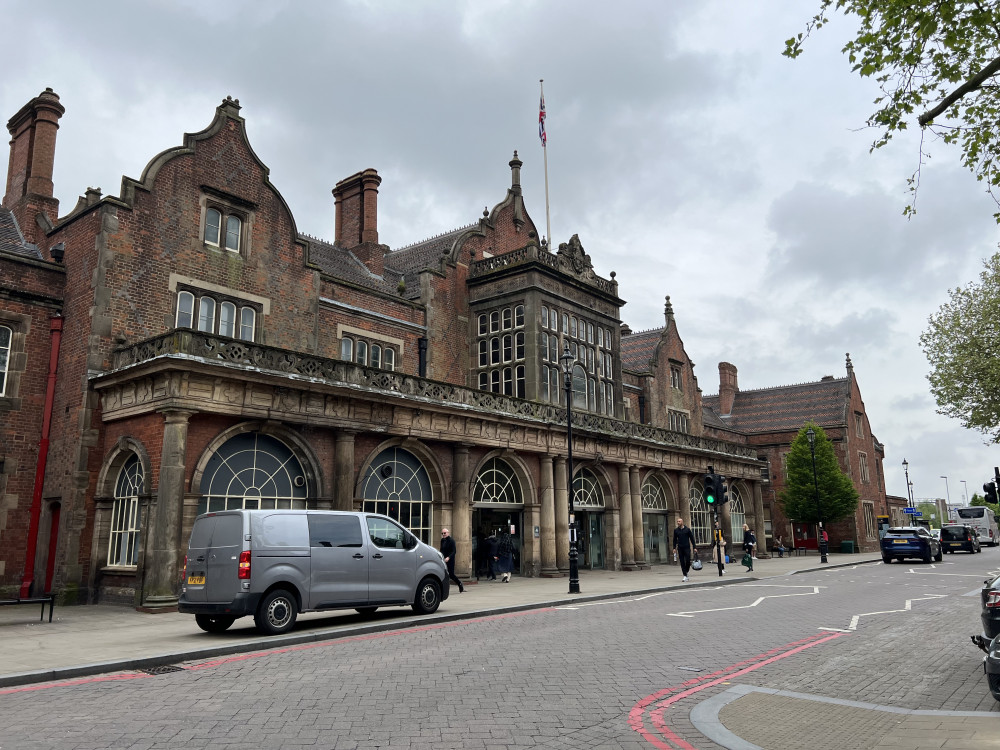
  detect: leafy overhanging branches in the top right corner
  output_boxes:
[783,0,1000,222]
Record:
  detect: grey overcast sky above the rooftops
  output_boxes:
[0,0,1000,516]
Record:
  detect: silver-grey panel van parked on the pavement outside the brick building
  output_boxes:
[178,510,449,634]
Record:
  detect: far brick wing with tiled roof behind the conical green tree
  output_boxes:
[703,355,890,552]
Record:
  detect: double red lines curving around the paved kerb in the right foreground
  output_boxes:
[628,633,847,750]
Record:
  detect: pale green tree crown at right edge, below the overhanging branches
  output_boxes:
[920,254,1000,443]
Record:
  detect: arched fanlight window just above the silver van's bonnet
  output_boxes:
[361,448,433,542]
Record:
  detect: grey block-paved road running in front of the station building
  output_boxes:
[0,549,1000,750]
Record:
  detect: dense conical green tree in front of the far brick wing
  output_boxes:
[778,422,858,523]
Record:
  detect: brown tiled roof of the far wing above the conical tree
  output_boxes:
[702,378,851,434]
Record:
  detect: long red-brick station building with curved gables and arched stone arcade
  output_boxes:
[0,89,880,609]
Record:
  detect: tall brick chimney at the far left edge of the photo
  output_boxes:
[3,89,66,245]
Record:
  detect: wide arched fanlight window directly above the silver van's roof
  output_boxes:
[198,432,308,513]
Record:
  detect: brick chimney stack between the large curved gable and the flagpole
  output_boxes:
[333,169,386,276]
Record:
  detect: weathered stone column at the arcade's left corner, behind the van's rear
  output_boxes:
[142,409,193,611]
